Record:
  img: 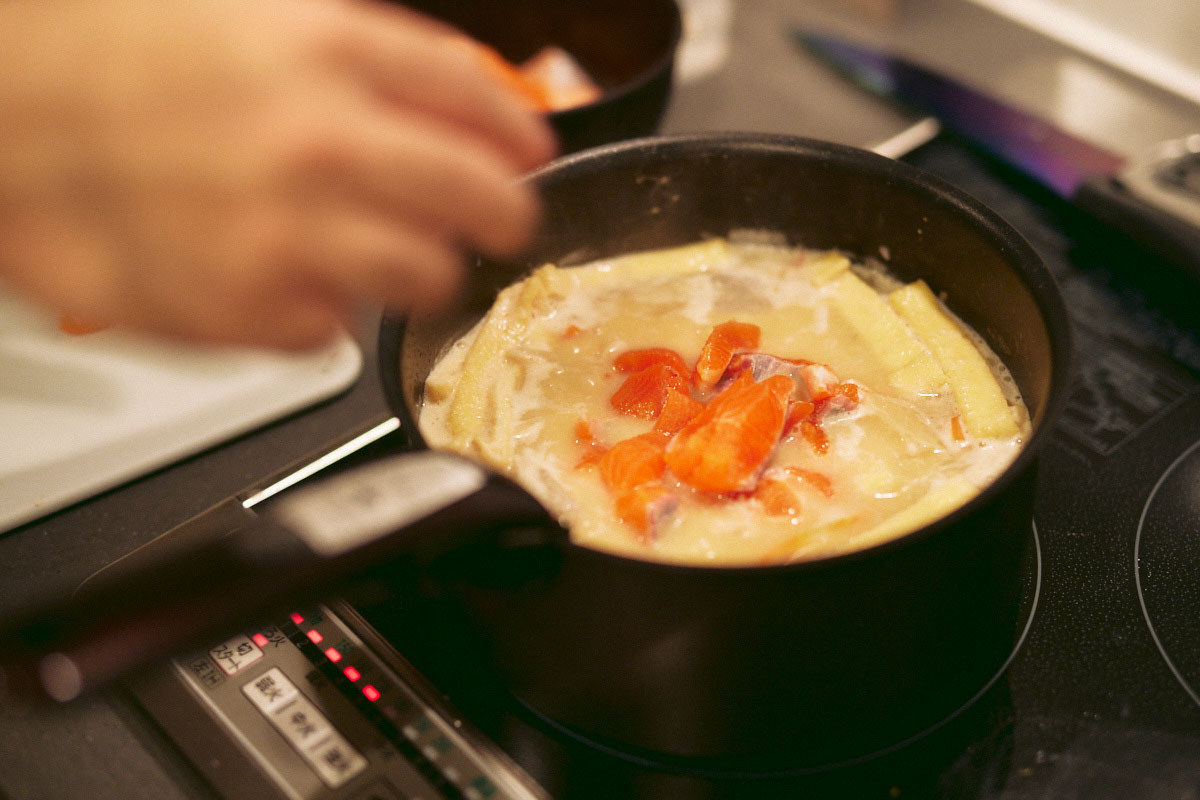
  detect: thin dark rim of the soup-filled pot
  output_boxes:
[379,131,1073,579]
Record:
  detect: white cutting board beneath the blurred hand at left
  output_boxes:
[0,293,362,531]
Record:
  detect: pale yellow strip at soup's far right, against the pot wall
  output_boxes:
[888,281,1019,439]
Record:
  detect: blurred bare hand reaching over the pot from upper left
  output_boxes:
[0,0,556,349]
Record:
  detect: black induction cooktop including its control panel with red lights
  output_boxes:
[119,138,1200,800]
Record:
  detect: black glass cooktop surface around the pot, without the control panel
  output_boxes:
[124,138,1200,800]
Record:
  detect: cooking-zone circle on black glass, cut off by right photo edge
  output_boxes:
[1133,441,1200,705]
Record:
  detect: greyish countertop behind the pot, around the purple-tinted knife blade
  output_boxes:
[665,0,1200,163]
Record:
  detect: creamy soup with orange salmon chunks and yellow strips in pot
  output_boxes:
[419,236,1030,565]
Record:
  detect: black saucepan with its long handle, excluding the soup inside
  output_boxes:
[0,134,1069,765]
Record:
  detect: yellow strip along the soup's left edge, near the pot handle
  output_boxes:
[446,264,570,467]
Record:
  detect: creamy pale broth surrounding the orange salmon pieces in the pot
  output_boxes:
[420,240,1028,565]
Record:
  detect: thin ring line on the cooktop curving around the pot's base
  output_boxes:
[516,522,1041,780]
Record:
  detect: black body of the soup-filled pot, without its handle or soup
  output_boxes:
[379,134,1069,766]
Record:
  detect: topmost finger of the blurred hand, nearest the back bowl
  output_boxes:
[346,4,557,172]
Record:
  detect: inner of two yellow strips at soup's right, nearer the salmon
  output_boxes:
[833,270,946,393]
